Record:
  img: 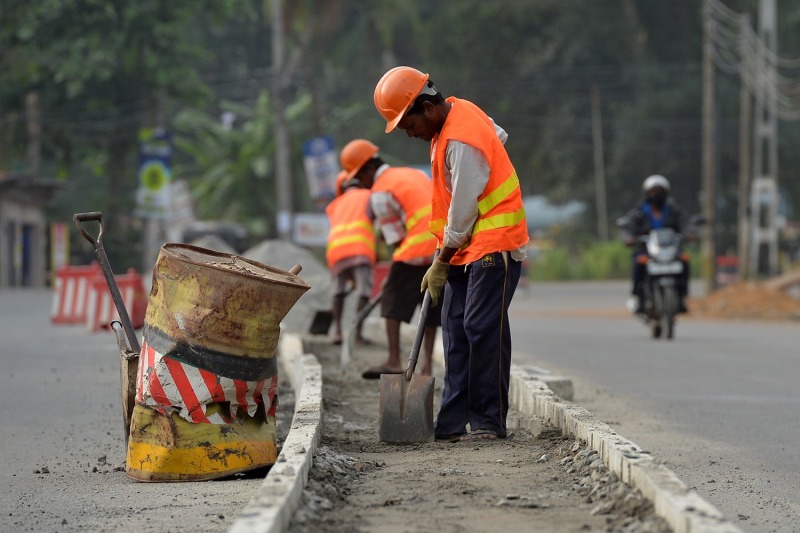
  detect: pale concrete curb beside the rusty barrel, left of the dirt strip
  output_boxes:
[228,333,322,533]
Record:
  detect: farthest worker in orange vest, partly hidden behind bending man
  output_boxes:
[325,171,376,344]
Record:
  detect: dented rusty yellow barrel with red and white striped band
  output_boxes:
[127,243,309,482]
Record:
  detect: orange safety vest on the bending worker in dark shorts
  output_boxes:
[372,167,436,261]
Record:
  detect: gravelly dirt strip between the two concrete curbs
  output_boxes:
[282,323,670,533]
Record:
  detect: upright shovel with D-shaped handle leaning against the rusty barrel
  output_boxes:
[72,211,141,440]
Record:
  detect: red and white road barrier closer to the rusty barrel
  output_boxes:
[86,268,147,332]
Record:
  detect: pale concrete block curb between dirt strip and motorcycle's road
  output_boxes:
[509,364,742,533]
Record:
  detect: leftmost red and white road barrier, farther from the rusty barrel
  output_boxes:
[50,261,103,324]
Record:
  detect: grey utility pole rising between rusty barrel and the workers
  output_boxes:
[272,0,292,240]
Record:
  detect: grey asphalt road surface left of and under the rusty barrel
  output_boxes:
[0,290,264,533]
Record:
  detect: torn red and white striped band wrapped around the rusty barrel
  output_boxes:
[136,342,278,424]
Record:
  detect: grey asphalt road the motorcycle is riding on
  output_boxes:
[511,282,800,532]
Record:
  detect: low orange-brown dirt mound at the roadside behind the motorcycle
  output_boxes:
[688,281,800,320]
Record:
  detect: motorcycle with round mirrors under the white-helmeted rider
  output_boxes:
[617,215,704,339]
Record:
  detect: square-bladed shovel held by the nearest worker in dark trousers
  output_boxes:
[378,291,435,444]
